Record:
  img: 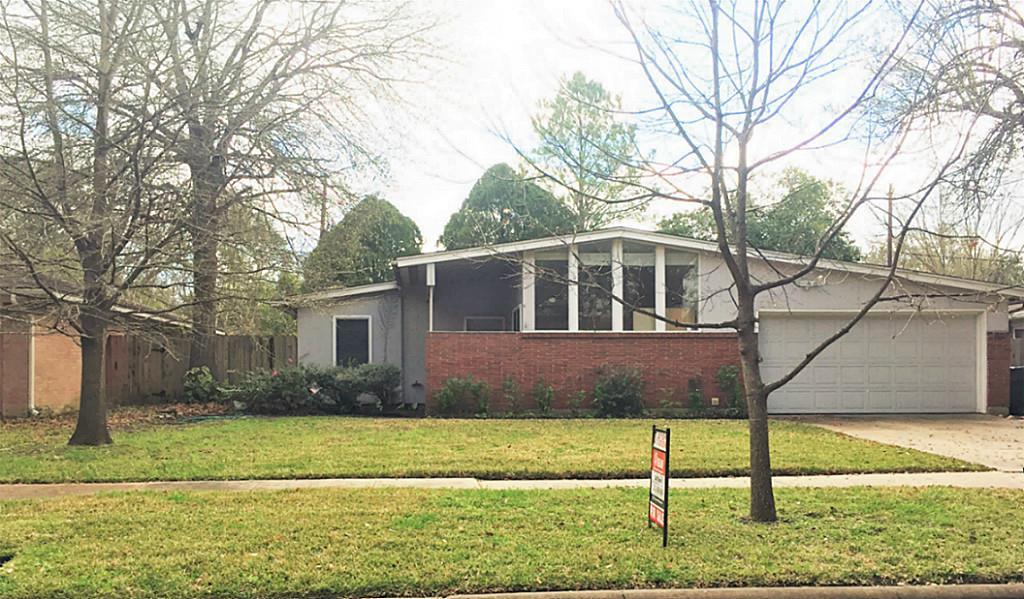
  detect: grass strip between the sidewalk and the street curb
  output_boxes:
[0,488,1024,598]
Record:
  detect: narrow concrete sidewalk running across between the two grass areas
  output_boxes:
[0,472,1024,500]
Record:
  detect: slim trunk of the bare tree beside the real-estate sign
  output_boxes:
[737,298,776,522]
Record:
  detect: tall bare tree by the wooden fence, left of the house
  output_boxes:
[138,0,432,367]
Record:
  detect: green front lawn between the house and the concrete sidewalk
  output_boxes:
[0,417,983,482]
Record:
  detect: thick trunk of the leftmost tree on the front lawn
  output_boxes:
[68,314,112,445]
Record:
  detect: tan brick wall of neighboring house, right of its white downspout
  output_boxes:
[35,326,82,412]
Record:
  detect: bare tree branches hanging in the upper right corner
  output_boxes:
[879,0,1024,212]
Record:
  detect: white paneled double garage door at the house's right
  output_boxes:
[758,312,978,414]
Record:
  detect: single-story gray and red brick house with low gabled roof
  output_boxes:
[293,227,1024,414]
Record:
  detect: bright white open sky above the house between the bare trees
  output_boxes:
[348,0,946,250]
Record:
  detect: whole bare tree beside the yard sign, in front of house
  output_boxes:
[507,0,971,522]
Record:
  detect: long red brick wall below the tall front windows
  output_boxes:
[426,333,739,411]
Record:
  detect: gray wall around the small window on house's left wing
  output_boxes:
[297,291,401,367]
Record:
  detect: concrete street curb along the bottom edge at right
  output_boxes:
[444,584,1024,599]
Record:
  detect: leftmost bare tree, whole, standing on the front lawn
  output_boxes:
[0,0,184,445]
